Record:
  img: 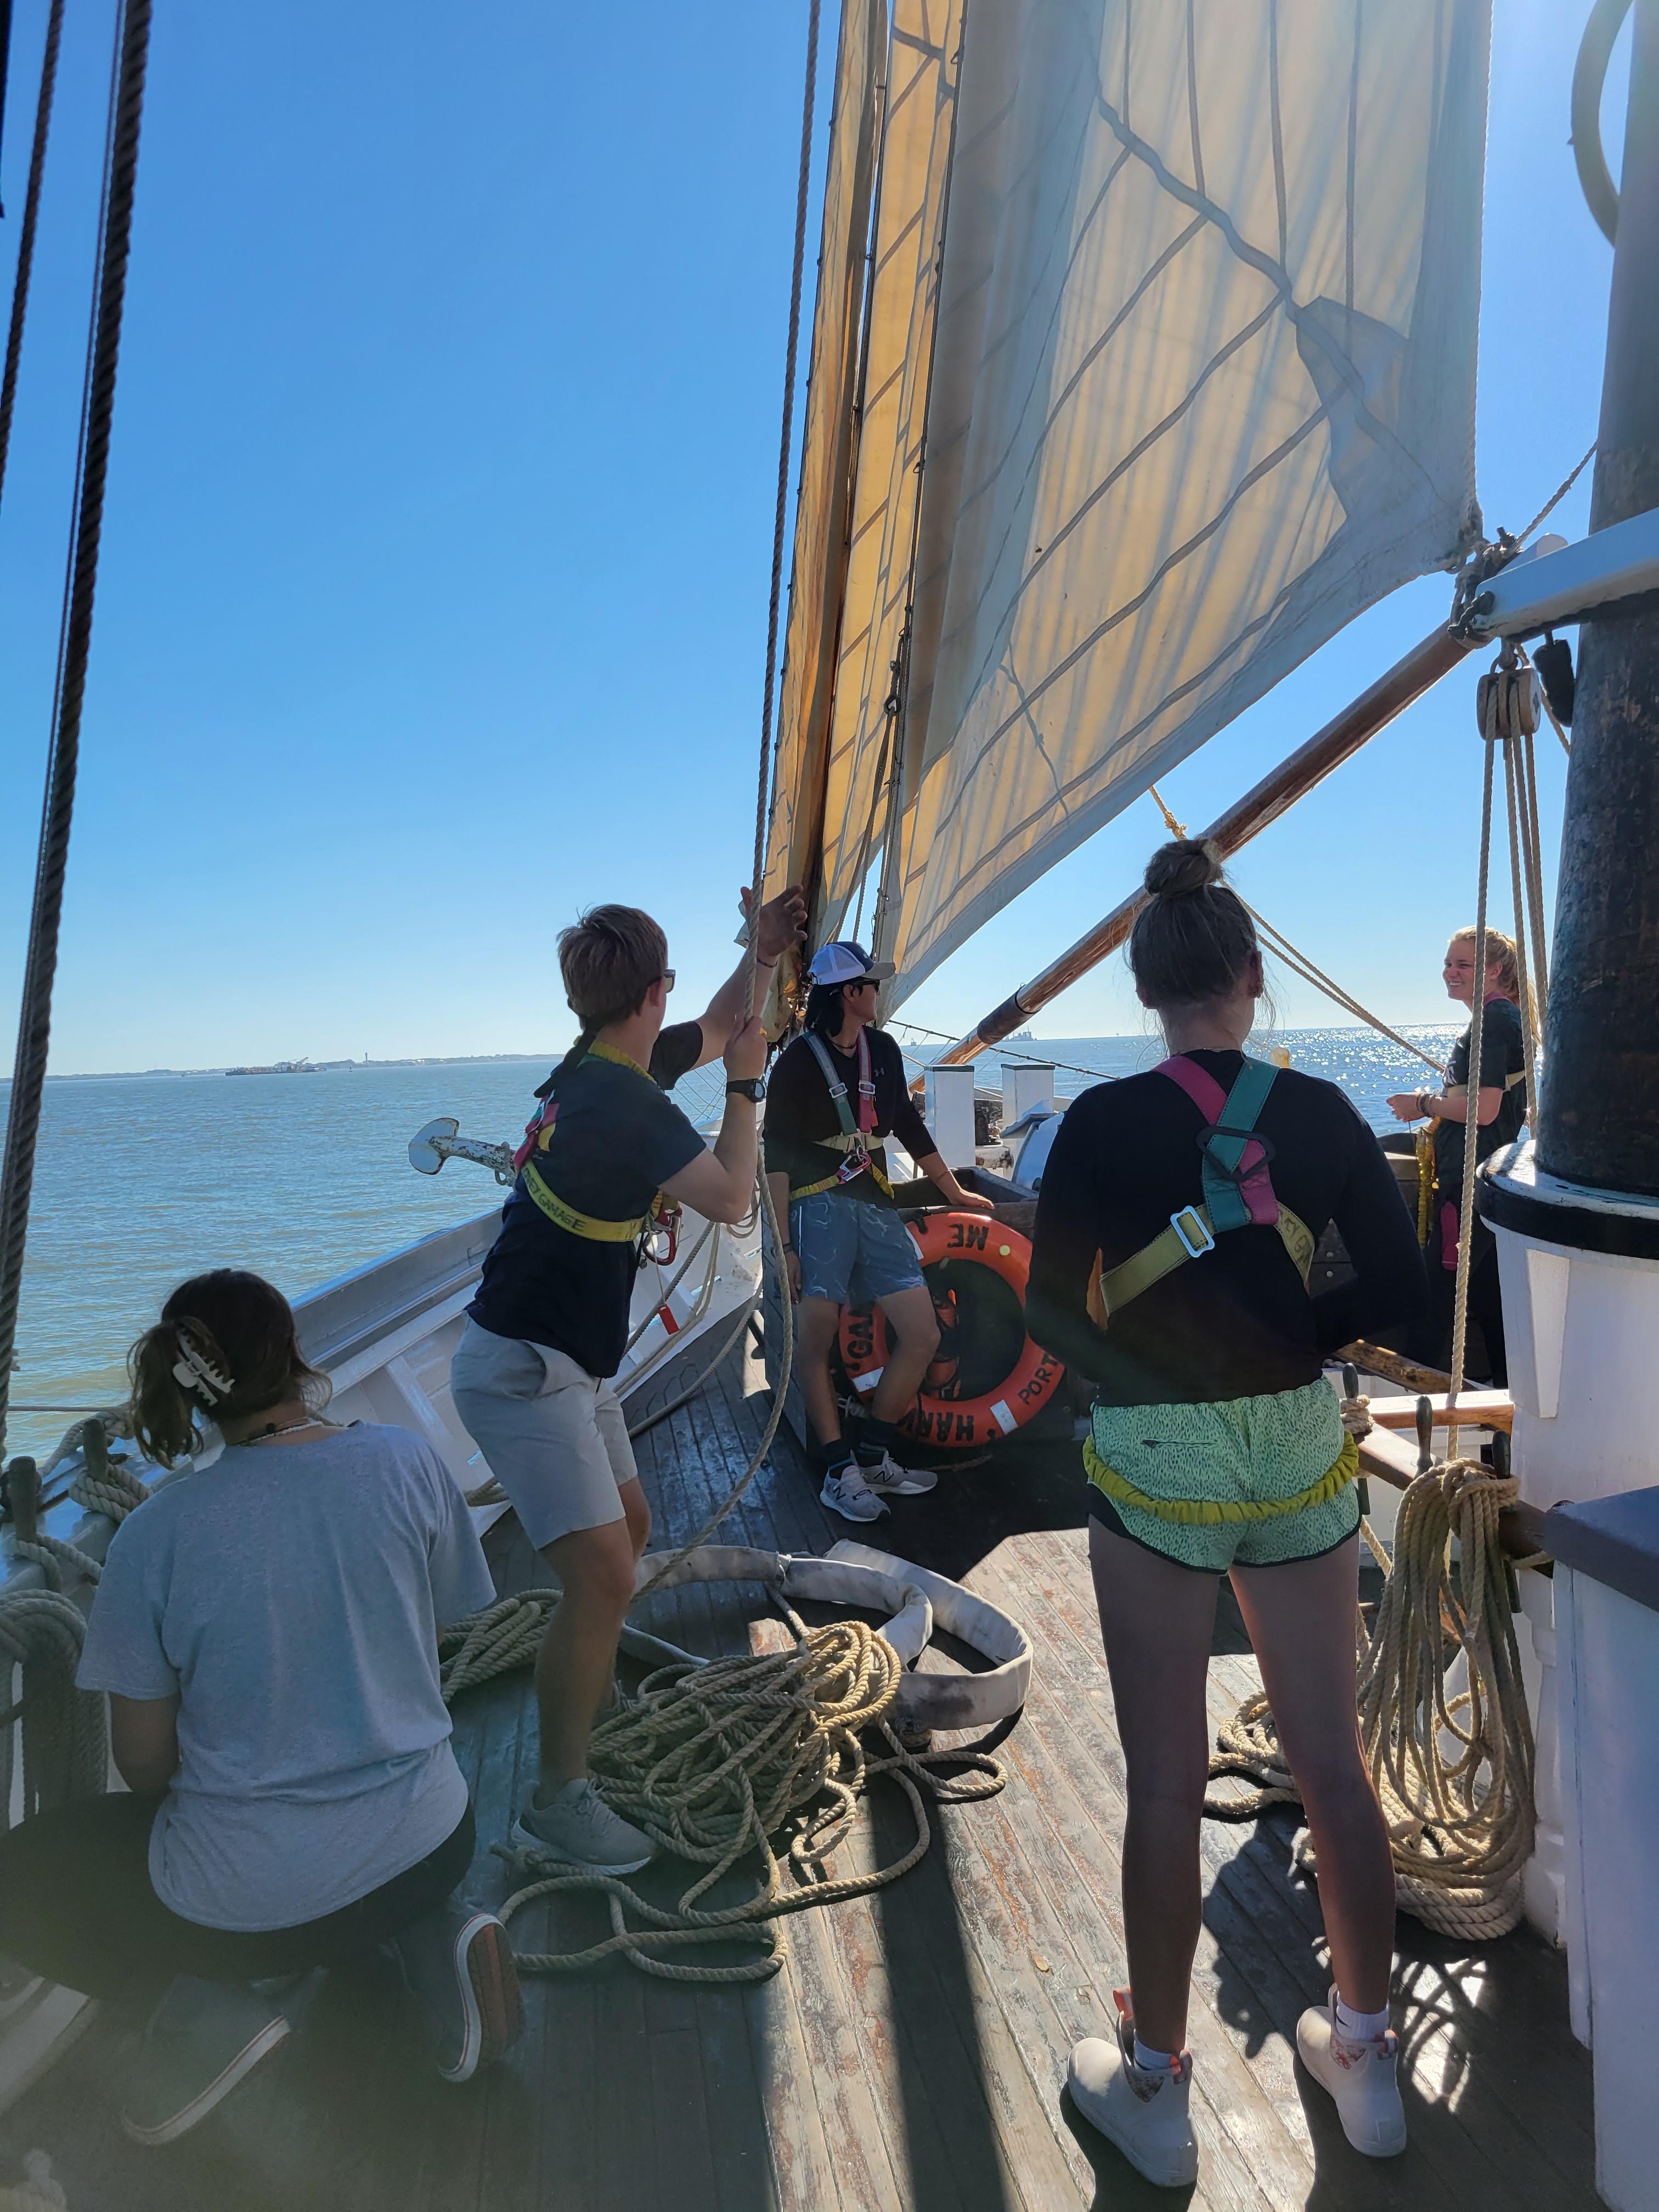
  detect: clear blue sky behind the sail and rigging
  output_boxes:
[0,0,1628,1073]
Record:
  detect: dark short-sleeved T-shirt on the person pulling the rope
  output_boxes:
[467,1022,703,1376]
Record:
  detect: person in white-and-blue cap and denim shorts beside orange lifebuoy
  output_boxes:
[765,945,991,1522]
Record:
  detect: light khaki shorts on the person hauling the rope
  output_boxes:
[449,1318,639,1550]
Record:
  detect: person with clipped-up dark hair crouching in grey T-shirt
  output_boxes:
[0,1267,522,2143]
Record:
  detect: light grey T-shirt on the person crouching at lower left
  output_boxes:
[77,1423,495,1929]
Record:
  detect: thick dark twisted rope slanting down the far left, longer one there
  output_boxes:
[0,0,150,1449]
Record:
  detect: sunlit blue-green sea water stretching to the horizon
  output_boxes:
[0,1024,1455,1451]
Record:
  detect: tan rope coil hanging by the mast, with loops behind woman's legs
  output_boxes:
[1205,1460,1535,1940]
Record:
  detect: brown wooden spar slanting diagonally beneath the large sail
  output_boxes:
[938,630,1471,1066]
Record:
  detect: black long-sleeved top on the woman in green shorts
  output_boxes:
[1026,1053,1427,1404]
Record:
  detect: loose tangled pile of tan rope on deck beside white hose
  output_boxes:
[495,1612,1005,1982]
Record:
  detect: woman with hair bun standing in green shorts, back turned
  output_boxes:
[1026,840,1425,2186]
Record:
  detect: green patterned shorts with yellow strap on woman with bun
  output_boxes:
[1084,1378,1361,1575]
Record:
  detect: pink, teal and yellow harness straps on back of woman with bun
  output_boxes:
[1088,1053,1314,1329]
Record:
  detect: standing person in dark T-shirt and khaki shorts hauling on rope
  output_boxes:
[449,889,805,1874]
